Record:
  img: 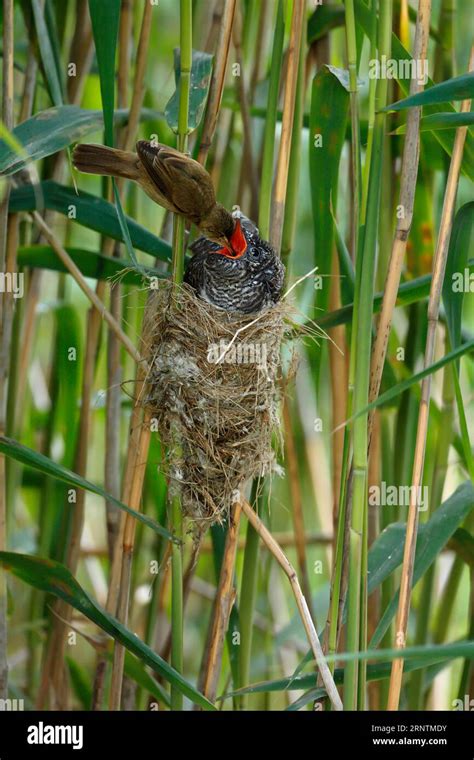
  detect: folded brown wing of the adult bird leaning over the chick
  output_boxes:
[136,140,216,223]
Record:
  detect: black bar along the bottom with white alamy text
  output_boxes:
[0,710,474,760]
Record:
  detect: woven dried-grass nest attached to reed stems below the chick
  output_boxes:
[144,283,289,533]
